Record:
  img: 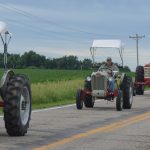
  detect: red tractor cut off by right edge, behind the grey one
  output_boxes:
[134,63,150,95]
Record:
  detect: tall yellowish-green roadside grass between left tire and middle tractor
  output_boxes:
[31,79,83,108]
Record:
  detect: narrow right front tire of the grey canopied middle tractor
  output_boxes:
[116,90,123,111]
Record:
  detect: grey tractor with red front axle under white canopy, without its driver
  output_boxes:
[76,40,133,111]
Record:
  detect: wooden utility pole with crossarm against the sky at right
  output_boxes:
[129,34,145,66]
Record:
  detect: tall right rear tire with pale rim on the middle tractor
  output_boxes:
[123,76,133,109]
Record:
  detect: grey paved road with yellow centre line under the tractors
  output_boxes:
[0,92,150,150]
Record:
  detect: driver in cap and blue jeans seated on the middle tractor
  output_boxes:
[99,57,119,92]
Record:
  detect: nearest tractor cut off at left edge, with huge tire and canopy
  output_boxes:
[0,22,31,136]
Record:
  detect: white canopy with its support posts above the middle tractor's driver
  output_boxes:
[90,39,124,66]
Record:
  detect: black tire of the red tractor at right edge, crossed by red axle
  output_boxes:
[135,66,144,95]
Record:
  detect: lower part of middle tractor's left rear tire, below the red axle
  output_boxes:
[84,95,95,108]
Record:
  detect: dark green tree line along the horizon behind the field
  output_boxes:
[0,51,130,71]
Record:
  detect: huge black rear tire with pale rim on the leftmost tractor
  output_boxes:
[4,75,31,136]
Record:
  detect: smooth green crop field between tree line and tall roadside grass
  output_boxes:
[14,69,92,83]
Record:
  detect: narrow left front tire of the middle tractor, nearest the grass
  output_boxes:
[76,89,83,109]
